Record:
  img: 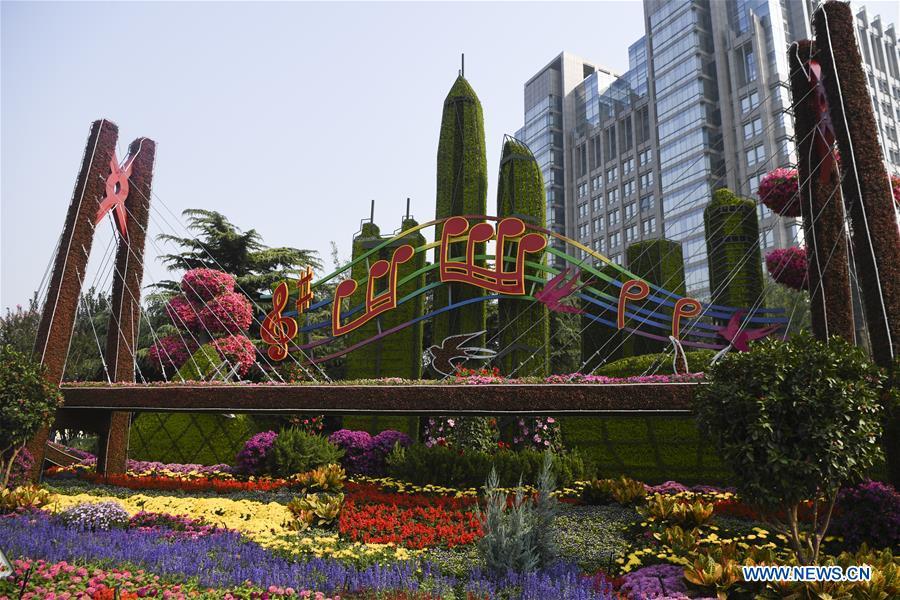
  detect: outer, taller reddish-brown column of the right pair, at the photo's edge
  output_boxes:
[813,2,900,484]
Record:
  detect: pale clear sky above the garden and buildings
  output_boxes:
[0,1,896,307]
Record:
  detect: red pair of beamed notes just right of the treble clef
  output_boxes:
[331,244,415,336]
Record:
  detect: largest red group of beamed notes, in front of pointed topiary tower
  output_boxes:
[440,217,547,295]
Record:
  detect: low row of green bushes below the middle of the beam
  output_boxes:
[387,444,589,487]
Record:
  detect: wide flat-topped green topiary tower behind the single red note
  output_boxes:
[626,239,686,356]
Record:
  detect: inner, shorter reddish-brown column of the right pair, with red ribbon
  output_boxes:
[788,40,856,344]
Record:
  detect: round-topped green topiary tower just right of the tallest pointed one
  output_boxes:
[497,138,550,377]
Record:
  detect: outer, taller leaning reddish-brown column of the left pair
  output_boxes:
[28,119,119,479]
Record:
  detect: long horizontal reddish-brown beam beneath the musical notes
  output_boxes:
[61,383,699,415]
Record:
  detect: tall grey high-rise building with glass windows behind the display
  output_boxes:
[519,0,900,298]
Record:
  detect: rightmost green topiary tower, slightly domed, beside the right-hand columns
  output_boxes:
[703,188,763,308]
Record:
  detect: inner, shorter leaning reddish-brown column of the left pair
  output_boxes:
[97,138,156,475]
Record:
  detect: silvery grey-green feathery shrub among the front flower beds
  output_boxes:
[478,452,559,574]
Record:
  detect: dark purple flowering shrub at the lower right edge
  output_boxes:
[834,481,900,548]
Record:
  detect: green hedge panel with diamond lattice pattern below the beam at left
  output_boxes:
[128,413,257,465]
